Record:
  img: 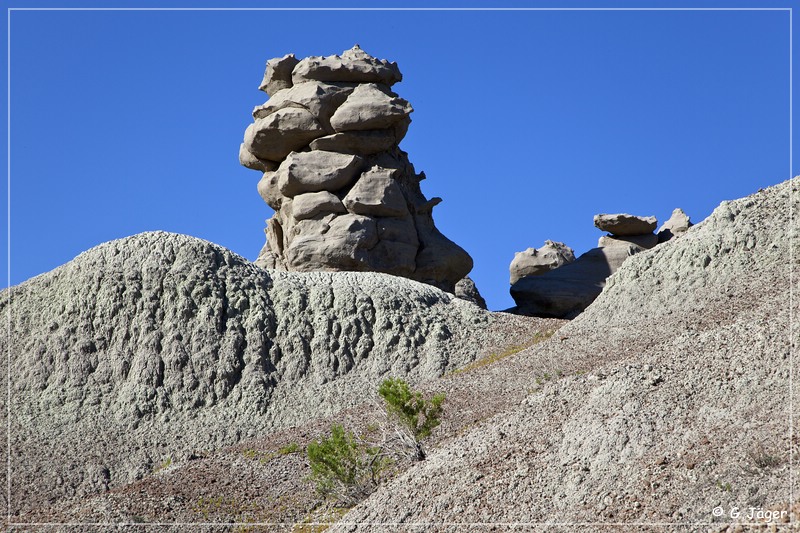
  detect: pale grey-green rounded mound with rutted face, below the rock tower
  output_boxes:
[0,232,493,515]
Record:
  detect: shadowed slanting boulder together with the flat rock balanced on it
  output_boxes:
[511,214,658,318]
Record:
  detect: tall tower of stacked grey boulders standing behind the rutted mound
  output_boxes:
[239,45,472,292]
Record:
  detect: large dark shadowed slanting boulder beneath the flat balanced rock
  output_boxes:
[511,235,655,318]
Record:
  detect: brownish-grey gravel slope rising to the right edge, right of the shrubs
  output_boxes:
[331,178,800,531]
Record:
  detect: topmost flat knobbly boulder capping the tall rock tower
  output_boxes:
[292,45,403,85]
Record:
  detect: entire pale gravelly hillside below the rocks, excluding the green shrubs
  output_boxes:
[2,178,800,531]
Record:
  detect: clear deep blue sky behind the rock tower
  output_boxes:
[0,0,798,309]
